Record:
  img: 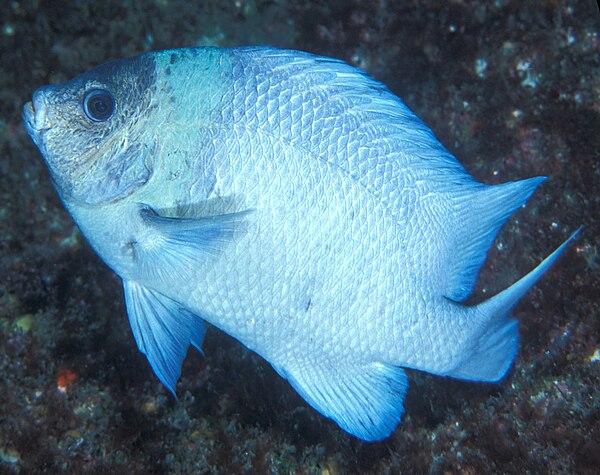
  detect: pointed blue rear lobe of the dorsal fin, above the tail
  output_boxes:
[443,177,546,302]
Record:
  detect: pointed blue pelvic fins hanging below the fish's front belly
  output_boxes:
[123,281,206,395]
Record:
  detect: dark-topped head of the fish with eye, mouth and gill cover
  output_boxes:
[23,55,157,205]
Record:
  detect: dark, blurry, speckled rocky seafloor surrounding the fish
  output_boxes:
[0,0,600,475]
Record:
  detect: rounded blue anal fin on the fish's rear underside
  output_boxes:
[277,361,408,441]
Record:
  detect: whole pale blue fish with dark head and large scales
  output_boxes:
[23,47,579,441]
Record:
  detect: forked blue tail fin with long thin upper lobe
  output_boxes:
[446,228,581,382]
